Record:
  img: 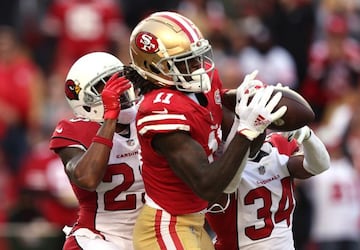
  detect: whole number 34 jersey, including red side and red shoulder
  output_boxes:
[207,134,298,250]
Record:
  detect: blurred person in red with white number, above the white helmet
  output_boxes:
[41,0,128,77]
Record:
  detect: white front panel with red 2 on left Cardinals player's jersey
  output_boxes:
[91,130,145,246]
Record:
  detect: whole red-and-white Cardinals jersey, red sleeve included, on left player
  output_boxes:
[50,119,145,249]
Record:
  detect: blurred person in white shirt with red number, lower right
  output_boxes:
[305,127,360,250]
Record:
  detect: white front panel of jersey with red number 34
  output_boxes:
[237,143,295,250]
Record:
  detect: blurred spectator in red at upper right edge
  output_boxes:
[300,15,360,121]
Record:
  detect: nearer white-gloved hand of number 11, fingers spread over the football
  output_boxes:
[235,86,287,141]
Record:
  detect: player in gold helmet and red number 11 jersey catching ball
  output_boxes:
[127,12,286,250]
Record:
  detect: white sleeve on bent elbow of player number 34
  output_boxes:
[302,131,330,175]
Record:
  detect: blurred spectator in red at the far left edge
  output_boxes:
[0,26,43,174]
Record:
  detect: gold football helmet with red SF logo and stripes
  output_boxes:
[130,11,215,92]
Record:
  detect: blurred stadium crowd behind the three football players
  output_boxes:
[0,0,360,250]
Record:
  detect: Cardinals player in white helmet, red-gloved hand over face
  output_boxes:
[50,52,144,250]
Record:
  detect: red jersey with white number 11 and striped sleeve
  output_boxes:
[136,71,222,215]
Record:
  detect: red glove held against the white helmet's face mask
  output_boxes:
[101,72,131,120]
